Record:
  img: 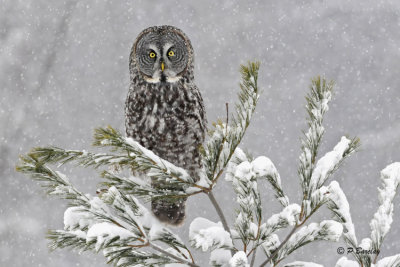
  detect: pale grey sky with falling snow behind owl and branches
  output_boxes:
[0,0,400,267]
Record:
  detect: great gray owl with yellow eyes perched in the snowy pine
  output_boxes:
[125,26,206,225]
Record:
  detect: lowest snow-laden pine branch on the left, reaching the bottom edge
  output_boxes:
[17,155,197,266]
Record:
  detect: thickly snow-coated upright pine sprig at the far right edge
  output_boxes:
[370,162,400,260]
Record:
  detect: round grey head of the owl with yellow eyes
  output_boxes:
[130,26,193,83]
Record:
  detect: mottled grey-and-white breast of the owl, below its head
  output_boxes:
[125,81,206,176]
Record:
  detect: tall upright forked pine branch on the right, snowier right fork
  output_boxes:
[298,77,360,228]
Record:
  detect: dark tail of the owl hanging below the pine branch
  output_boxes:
[151,199,186,226]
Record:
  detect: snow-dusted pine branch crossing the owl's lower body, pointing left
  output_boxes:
[24,127,207,203]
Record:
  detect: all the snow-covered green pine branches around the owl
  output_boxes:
[16,63,400,267]
